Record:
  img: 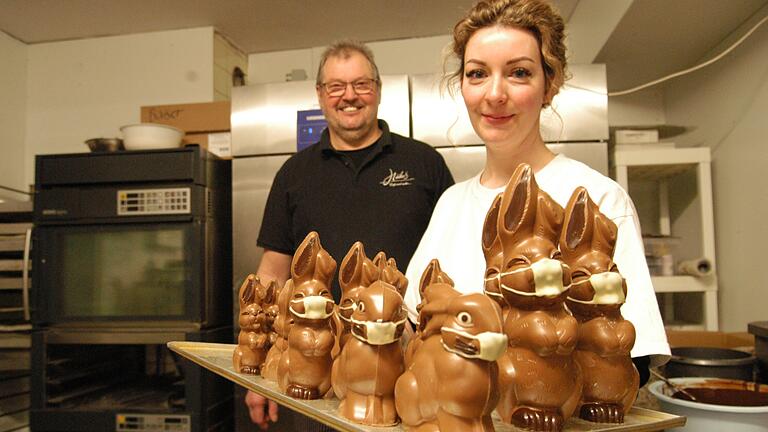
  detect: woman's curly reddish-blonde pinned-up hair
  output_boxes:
[448,0,567,105]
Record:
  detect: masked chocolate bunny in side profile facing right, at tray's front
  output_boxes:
[395,294,507,431]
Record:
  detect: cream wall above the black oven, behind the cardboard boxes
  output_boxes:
[24,27,214,187]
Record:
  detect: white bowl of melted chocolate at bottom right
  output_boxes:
[648,378,768,432]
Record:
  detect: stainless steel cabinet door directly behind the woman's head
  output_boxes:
[410,65,608,147]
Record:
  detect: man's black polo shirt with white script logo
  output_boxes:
[257,120,453,301]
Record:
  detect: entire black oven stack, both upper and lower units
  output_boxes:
[30,146,234,432]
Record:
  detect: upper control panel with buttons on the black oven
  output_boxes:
[117,188,192,216]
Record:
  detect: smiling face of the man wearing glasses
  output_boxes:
[317,52,381,147]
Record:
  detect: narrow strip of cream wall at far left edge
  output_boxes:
[0,32,29,195]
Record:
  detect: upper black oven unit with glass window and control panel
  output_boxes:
[32,146,232,330]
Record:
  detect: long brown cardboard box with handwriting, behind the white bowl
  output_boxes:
[141,101,232,133]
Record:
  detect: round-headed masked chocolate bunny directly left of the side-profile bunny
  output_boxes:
[331,280,408,426]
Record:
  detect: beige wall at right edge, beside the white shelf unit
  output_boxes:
[665,7,768,331]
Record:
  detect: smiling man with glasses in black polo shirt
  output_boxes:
[246,41,453,429]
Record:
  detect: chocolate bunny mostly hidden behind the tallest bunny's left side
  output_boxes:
[482,194,509,319]
